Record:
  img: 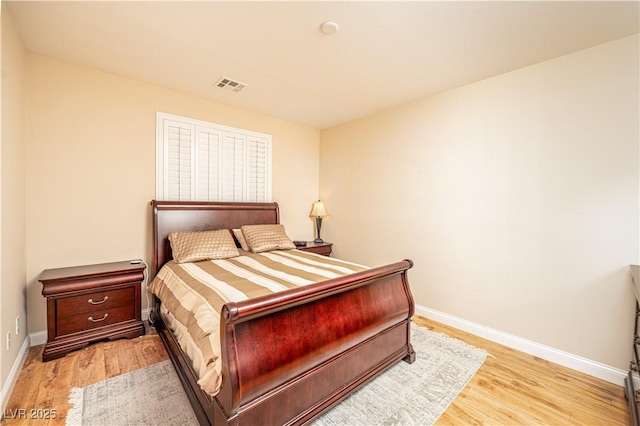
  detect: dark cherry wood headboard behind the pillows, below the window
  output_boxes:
[151,200,280,274]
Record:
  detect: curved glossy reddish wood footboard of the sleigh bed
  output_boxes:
[211,260,415,424]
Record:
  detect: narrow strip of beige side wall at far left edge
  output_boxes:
[0,4,27,388]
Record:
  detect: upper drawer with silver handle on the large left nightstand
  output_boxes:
[56,287,135,317]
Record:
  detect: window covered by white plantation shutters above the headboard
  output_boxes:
[156,112,271,202]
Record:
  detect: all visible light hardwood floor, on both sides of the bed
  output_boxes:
[2,317,629,426]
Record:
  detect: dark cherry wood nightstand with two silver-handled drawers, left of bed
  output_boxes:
[38,261,146,361]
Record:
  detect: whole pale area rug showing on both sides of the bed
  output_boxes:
[67,325,487,426]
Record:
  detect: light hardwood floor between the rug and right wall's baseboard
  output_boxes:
[414,317,629,425]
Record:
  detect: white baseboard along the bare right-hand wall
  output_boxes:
[416,305,627,386]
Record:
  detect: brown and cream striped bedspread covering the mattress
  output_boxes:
[148,250,368,395]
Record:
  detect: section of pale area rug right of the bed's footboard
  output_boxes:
[313,324,488,426]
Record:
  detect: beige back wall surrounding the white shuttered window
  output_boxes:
[26,54,319,332]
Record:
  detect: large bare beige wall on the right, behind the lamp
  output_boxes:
[320,36,640,369]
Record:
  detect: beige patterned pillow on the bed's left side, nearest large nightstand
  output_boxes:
[169,229,240,263]
